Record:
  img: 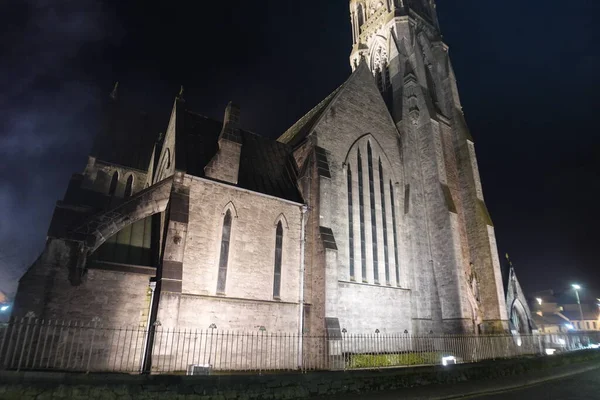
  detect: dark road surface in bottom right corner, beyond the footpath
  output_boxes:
[469,370,600,400]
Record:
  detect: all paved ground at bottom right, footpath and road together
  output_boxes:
[314,362,600,400]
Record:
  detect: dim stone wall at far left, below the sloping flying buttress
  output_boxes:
[13,239,150,327]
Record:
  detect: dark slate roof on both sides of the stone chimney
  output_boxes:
[177,110,303,203]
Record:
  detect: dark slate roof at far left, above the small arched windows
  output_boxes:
[90,100,164,171]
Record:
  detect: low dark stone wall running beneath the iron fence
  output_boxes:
[0,350,600,400]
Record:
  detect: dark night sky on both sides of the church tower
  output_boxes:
[0,0,600,304]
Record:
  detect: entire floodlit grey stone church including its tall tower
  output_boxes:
[14,0,508,335]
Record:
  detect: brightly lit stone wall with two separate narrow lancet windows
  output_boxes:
[158,176,302,332]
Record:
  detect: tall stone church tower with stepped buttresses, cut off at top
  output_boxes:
[342,0,507,332]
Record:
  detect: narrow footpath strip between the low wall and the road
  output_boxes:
[313,361,600,400]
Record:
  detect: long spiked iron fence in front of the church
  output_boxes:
[0,318,600,374]
